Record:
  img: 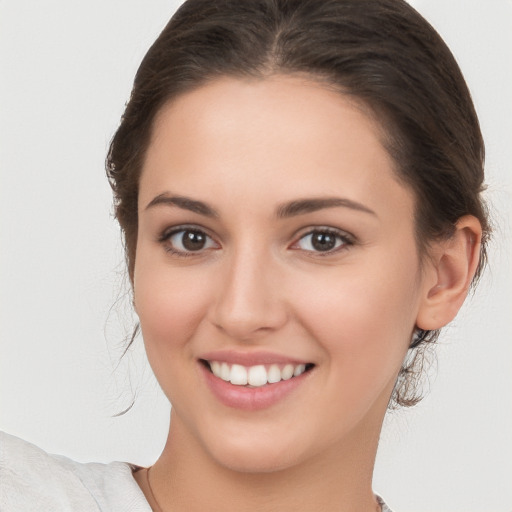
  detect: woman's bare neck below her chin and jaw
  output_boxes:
[145,408,382,512]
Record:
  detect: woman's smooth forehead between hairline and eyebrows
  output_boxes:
[140,75,412,220]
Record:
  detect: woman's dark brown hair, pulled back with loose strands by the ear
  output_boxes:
[107,0,489,405]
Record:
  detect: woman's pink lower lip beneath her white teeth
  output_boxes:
[199,363,311,411]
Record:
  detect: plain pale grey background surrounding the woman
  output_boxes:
[0,0,512,512]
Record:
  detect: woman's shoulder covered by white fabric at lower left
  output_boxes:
[0,432,151,512]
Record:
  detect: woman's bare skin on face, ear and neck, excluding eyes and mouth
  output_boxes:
[133,75,480,512]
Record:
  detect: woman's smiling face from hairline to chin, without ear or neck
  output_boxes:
[134,76,425,471]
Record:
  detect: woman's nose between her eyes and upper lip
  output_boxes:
[210,248,288,341]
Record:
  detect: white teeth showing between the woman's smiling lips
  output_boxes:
[200,359,315,388]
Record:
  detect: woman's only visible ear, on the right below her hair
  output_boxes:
[416,215,482,330]
